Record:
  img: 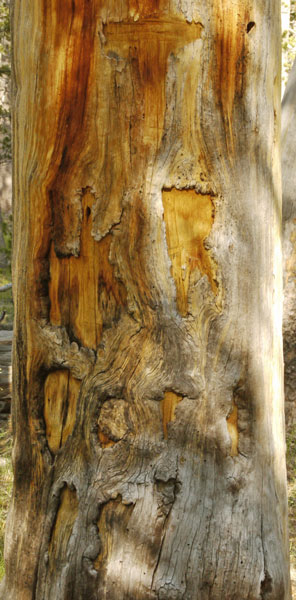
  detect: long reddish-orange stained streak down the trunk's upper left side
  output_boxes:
[26,0,97,317]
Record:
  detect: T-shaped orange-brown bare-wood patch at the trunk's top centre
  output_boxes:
[104,17,202,147]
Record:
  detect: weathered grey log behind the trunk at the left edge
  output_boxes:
[0,331,13,424]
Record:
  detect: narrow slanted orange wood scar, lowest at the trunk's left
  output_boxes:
[48,486,78,573]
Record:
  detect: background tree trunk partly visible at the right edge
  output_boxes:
[282,61,296,427]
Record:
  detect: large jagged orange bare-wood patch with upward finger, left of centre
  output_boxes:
[49,191,126,349]
